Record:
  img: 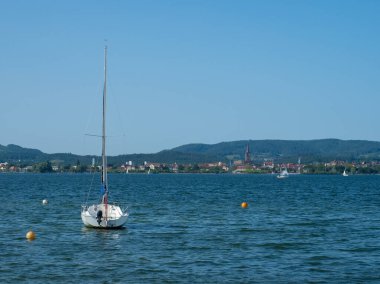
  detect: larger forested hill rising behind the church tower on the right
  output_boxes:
[172,139,380,162]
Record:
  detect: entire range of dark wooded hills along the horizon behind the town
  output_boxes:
[0,139,380,165]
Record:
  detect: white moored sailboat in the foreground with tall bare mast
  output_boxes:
[81,46,128,229]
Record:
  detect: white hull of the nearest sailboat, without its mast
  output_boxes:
[81,204,128,229]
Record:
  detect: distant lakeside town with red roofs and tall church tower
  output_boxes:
[0,145,380,175]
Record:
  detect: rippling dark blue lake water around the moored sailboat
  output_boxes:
[0,174,380,283]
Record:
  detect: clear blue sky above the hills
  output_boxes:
[0,0,380,155]
